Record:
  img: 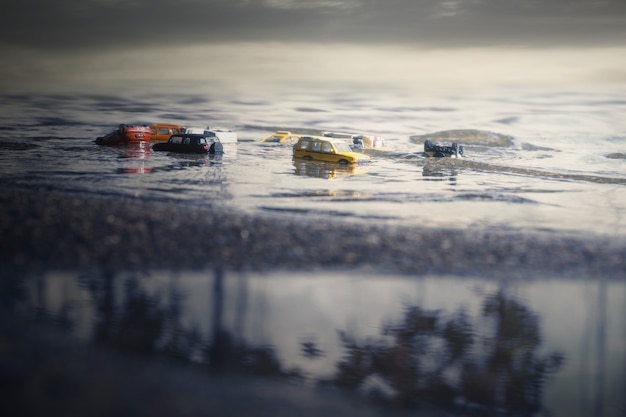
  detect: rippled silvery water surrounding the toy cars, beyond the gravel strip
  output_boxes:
[0,83,626,238]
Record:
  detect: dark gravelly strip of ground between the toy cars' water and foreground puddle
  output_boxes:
[0,188,626,278]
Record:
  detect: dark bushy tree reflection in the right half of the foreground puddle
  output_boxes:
[330,292,564,415]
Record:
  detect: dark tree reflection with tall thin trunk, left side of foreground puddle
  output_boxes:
[81,268,300,377]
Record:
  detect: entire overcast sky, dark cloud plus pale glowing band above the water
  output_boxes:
[0,0,626,91]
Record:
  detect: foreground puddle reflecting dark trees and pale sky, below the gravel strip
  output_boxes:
[2,268,626,416]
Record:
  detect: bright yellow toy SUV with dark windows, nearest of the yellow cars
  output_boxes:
[293,136,370,164]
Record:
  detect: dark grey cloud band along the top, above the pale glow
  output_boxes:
[0,0,626,49]
